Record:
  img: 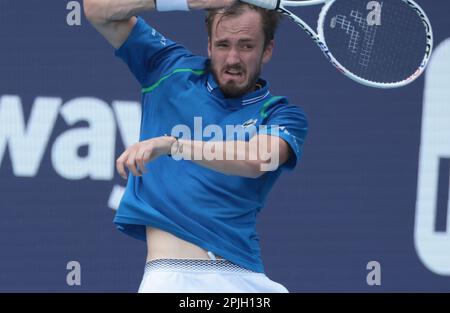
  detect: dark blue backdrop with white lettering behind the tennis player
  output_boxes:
[0,0,450,292]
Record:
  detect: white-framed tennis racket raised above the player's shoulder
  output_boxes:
[243,0,433,88]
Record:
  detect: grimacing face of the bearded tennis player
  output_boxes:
[208,9,273,97]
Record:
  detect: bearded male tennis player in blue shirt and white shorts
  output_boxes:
[84,0,307,292]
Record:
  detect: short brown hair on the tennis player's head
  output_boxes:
[205,1,281,47]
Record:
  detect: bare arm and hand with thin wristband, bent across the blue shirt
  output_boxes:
[116,135,290,179]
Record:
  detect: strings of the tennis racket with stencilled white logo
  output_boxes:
[322,0,427,83]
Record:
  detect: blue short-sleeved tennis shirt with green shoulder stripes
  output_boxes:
[114,18,307,272]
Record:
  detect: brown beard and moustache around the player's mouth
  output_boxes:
[210,60,261,98]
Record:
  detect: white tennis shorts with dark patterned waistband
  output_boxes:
[139,259,289,293]
